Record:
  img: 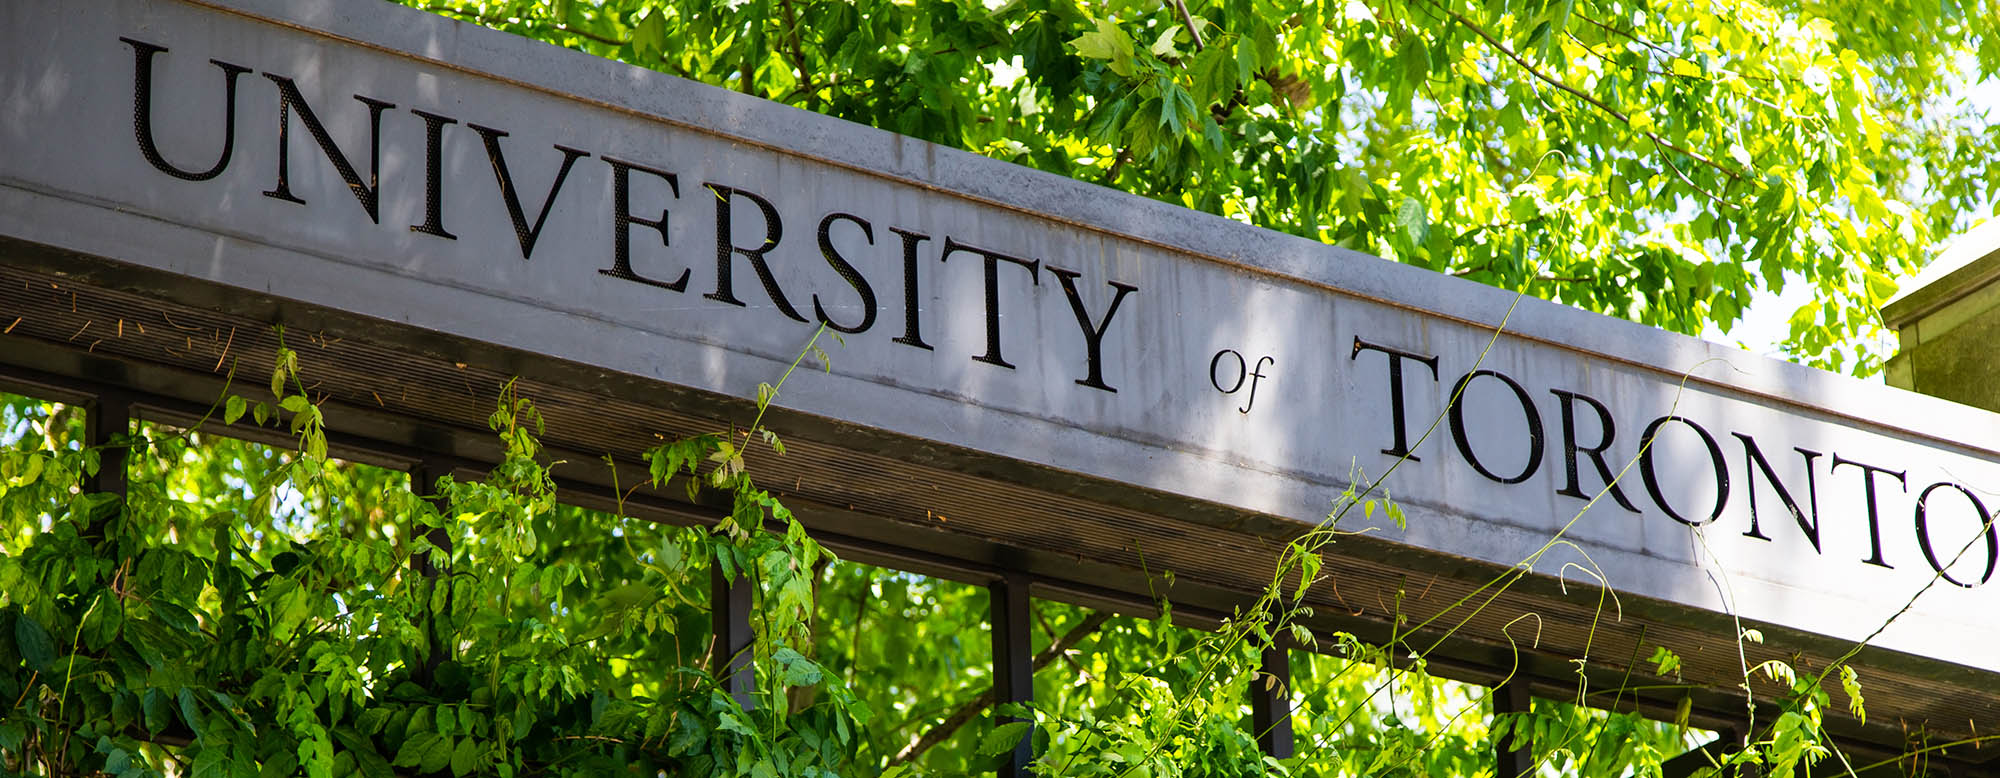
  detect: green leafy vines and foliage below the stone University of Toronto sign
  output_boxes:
[0,352,1860,778]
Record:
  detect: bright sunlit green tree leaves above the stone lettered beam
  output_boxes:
[408,0,2000,374]
